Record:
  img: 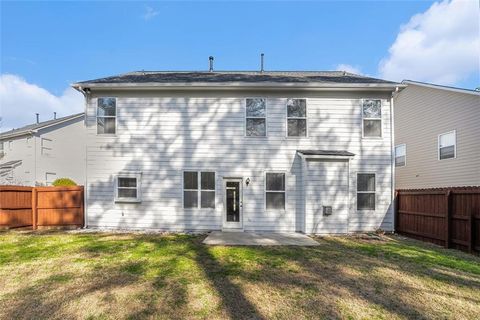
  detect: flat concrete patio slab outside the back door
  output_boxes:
[203,231,319,246]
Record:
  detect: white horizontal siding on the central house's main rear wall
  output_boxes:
[87,91,393,232]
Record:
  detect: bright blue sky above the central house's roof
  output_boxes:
[0,0,480,127]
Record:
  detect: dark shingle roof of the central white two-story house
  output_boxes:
[76,71,397,85]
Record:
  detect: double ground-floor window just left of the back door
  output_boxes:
[183,171,215,209]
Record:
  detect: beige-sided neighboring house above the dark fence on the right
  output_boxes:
[394,80,480,189]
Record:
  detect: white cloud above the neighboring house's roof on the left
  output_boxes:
[0,74,84,132]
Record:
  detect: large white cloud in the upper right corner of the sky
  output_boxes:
[379,0,480,85]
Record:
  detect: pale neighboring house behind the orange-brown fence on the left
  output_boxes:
[0,113,85,186]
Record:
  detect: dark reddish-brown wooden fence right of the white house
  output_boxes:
[395,187,480,252]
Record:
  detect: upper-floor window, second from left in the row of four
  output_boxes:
[245,98,267,137]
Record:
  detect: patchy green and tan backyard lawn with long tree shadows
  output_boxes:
[0,231,480,319]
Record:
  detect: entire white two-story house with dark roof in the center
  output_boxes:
[73,71,403,234]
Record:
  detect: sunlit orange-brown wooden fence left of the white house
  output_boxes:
[0,186,84,229]
